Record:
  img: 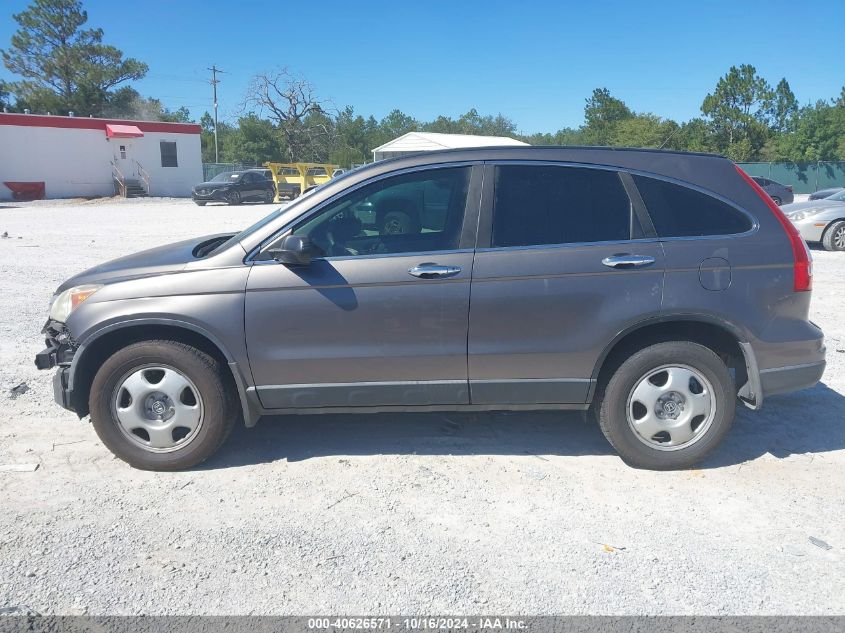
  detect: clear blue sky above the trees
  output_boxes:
[0,0,845,133]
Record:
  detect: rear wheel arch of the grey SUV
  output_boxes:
[588,314,760,408]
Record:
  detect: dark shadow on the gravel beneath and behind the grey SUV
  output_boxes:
[200,383,845,469]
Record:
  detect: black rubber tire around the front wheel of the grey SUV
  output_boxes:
[89,340,239,471]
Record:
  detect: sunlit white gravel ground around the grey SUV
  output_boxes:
[0,200,845,614]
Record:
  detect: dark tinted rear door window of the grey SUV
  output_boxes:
[492,165,639,247]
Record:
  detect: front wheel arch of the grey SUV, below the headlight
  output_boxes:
[68,319,259,426]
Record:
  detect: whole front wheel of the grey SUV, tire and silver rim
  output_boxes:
[89,340,238,471]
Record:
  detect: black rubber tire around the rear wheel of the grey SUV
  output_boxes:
[596,341,736,470]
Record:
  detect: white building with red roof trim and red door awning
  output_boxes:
[0,113,202,200]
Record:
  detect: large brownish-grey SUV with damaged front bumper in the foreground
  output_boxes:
[36,147,825,470]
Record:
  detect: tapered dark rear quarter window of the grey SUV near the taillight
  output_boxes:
[633,176,753,237]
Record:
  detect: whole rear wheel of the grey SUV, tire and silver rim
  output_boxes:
[598,341,736,470]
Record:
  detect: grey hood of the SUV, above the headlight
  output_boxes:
[56,233,233,292]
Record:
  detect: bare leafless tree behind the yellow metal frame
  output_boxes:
[243,67,334,161]
